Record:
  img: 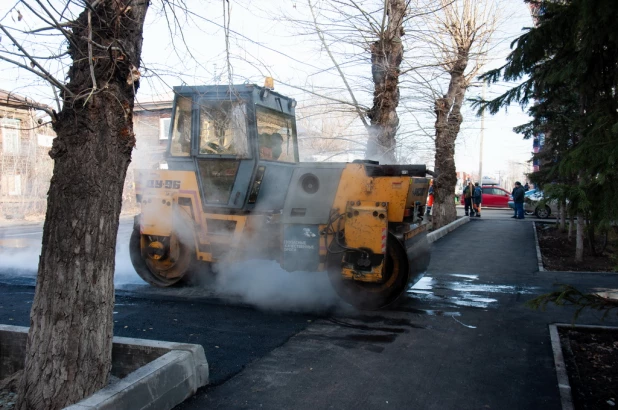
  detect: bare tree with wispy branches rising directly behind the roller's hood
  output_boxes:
[276,0,435,163]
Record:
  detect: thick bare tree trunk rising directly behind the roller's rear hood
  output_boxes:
[365,0,407,164]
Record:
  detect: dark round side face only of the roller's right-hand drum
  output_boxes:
[328,234,410,310]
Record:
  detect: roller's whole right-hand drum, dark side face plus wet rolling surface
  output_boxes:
[328,232,429,310]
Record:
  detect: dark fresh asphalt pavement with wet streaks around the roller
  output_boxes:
[0,210,617,410]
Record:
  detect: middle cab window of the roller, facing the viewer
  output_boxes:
[199,101,250,158]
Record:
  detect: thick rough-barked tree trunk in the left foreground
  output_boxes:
[17,0,148,410]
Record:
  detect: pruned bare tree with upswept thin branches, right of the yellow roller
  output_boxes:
[426,0,497,228]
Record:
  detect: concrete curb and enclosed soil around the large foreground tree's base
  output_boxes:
[0,325,209,410]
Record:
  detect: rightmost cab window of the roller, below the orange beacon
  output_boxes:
[256,106,297,162]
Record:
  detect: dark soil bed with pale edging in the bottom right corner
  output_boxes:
[559,328,618,410]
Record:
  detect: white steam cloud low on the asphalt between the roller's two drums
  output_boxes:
[202,259,349,313]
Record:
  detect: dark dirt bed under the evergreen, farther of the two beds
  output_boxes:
[536,224,618,272]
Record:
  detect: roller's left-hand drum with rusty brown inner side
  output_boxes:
[129,226,193,287]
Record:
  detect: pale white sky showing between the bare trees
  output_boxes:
[0,0,532,179]
